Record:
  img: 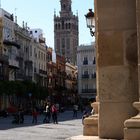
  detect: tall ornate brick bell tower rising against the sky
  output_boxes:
[54,0,79,64]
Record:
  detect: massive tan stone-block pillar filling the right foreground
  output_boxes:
[95,0,138,139]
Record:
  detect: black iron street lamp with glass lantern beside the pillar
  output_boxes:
[85,9,95,36]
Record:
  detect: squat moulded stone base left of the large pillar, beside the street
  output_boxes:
[83,115,98,136]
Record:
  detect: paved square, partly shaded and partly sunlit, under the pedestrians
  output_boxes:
[0,111,82,140]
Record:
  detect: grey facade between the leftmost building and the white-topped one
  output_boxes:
[14,23,33,81]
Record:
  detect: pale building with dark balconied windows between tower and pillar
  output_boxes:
[77,44,96,99]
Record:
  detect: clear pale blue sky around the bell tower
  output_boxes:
[0,0,94,48]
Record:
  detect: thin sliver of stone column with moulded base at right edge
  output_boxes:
[124,0,140,140]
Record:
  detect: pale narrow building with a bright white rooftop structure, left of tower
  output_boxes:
[30,28,47,87]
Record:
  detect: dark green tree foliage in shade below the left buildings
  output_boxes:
[0,81,48,99]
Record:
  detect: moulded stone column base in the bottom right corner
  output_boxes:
[124,102,140,140]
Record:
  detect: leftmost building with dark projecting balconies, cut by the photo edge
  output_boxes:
[0,8,20,80]
